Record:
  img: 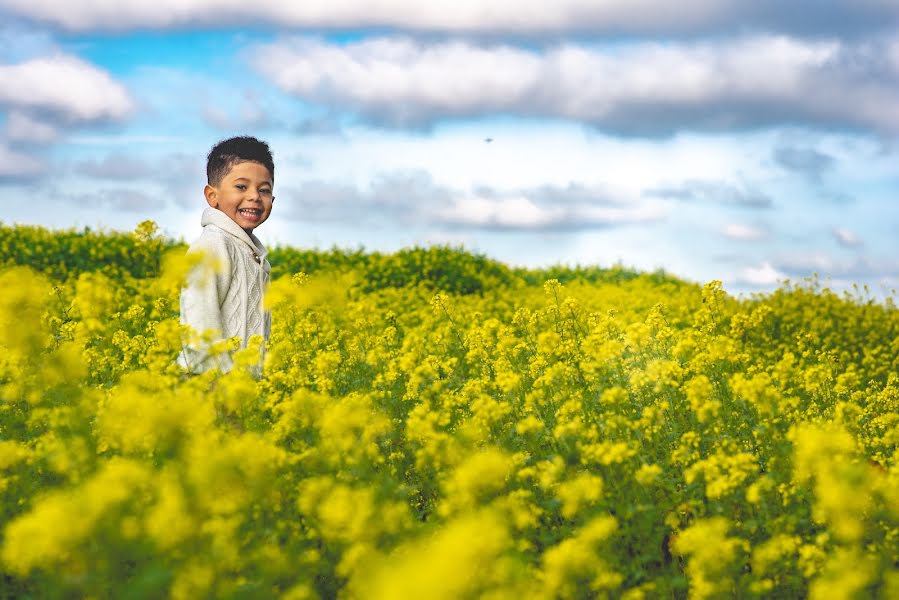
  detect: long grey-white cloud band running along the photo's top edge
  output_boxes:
[0,0,899,35]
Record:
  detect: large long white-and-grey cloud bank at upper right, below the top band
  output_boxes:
[250,35,899,136]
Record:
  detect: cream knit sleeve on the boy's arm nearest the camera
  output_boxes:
[181,235,232,373]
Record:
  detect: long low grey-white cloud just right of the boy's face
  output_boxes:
[276,171,665,231]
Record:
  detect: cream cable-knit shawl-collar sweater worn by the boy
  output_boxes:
[179,208,272,373]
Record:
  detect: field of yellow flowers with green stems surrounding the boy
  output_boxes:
[0,223,899,599]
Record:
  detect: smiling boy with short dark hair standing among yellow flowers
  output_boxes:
[179,136,275,373]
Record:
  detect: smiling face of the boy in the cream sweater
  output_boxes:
[203,161,275,233]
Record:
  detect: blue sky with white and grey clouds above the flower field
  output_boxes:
[0,0,899,297]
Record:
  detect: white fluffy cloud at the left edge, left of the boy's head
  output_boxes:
[0,54,134,122]
